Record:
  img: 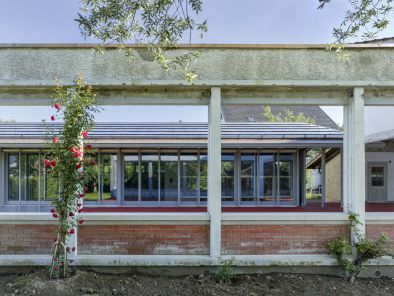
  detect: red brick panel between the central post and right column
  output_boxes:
[222,225,348,255]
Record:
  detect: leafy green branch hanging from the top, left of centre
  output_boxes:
[76,0,207,81]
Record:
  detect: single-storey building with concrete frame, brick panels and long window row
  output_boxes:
[0,44,394,266]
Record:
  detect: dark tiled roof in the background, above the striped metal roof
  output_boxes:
[222,105,338,129]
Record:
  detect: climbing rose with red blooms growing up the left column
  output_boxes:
[44,76,99,278]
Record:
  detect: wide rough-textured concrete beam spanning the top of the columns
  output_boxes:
[0,47,394,86]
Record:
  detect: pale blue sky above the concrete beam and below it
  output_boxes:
[0,0,394,134]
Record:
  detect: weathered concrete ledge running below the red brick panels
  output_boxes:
[0,254,394,267]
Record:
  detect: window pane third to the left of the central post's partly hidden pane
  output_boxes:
[141,154,159,201]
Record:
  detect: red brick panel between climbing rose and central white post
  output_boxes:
[78,225,209,255]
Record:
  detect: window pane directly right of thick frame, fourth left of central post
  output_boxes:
[124,155,138,201]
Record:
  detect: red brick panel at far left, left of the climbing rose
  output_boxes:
[0,224,56,255]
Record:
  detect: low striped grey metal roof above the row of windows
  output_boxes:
[0,122,342,140]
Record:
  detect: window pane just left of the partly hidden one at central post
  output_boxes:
[180,154,198,202]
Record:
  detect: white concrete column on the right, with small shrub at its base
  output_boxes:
[343,87,365,242]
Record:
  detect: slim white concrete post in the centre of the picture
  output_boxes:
[208,87,222,259]
